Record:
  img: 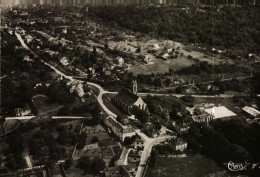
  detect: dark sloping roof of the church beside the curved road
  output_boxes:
[115,88,139,106]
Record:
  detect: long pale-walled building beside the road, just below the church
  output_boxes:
[104,116,135,141]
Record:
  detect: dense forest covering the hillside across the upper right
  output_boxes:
[90,6,260,56]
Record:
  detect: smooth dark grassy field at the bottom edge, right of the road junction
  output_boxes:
[145,154,228,177]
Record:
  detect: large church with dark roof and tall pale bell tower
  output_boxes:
[113,81,148,114]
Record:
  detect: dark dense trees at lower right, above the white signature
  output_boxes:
[186,119,260,176]
